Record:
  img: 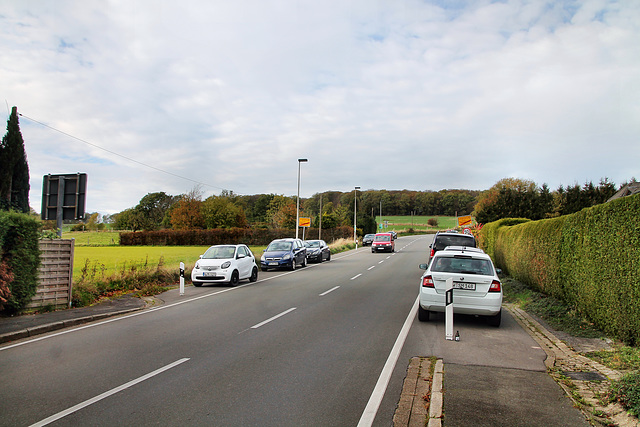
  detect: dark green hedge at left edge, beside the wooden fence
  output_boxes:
[0,211,40,313]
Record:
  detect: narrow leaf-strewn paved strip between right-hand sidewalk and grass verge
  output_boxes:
[505,304,640,427]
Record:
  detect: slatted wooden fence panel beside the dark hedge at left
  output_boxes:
[27,239,75,309]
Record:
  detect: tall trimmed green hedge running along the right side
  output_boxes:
[480,195,640,345]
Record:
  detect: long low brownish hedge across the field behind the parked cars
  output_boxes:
[120,227,353,246]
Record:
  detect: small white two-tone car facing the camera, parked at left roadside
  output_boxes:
[191,245,258,286]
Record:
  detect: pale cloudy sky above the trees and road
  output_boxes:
[0,0,640,213]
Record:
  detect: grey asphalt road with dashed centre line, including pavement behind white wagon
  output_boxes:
[0,236,584,426]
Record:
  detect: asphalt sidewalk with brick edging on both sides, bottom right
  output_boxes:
[393,305,640,427]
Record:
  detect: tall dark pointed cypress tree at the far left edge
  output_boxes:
[0,107,29,213]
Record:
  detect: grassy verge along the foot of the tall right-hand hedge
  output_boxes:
[501,277,640,416]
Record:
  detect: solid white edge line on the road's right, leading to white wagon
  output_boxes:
[358,296,420,427]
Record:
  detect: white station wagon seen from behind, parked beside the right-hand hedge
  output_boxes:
[418,248,502,326]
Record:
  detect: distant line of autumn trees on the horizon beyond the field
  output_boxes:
[110,188,479,233]
